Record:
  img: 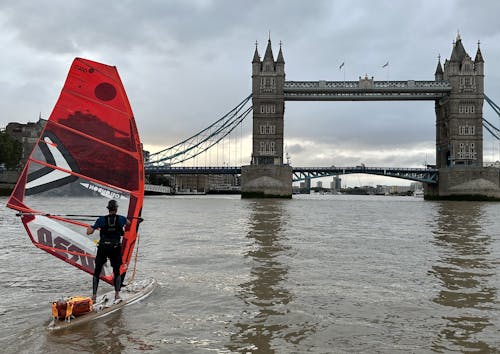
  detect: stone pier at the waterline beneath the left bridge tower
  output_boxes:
[241,165,293,198]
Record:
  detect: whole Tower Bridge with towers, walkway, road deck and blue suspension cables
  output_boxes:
[146,36,500,199]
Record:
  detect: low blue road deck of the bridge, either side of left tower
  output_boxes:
[145,166,438,184]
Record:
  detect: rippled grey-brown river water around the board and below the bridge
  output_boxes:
[0,195,500,353]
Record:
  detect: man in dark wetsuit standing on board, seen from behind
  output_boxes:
[87,199,130,301]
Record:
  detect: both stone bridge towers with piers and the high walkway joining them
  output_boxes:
[241,35,500,199]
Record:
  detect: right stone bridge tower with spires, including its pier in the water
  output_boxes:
[424,35,500,200]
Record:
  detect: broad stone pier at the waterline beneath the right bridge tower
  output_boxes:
[424,166,500,201]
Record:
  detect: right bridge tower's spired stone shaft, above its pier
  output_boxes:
[434,35,484,169]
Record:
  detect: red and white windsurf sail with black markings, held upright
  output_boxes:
[7,58,144,284]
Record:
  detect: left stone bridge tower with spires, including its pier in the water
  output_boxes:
[241,38,292,198]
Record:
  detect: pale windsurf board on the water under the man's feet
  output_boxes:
[47,278,158,330]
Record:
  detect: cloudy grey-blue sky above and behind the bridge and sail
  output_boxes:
[0,0,500,185]
